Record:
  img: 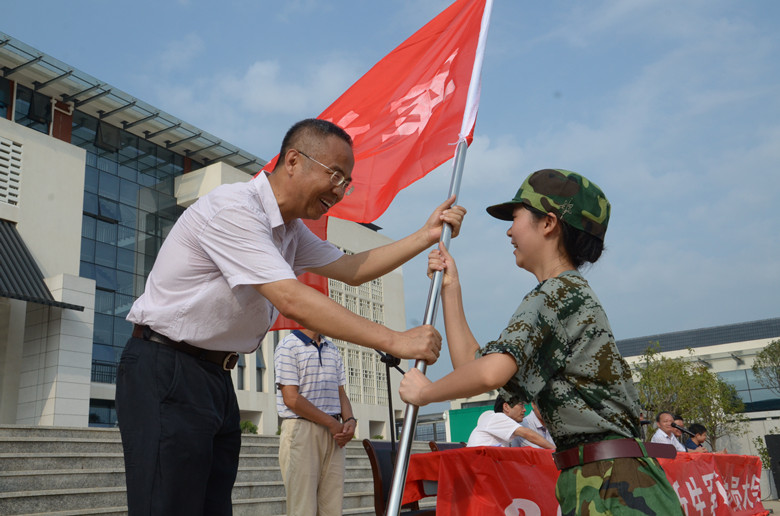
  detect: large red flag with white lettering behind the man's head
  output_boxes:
[263,0,486,330]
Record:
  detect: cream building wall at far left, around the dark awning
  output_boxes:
[0,119,95,426]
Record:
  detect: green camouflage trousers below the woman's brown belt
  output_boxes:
[555,458,683,516]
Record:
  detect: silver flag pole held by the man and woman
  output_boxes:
[385,0,493,516]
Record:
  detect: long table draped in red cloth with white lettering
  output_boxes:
[403,447,768,516]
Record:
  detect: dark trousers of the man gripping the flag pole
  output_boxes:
[116,338,241,516]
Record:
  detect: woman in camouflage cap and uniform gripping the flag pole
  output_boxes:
[401,169,682,516]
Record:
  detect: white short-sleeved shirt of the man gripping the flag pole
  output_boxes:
[127,174,342,353]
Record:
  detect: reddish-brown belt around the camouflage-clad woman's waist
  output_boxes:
[553,438,677,469]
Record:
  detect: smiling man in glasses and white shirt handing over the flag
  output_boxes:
[116,119,465,516]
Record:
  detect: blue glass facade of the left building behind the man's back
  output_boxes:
[71,111,190,426]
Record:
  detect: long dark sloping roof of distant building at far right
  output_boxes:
[617,317,780,357]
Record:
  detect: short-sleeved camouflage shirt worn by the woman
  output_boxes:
[478,271,639,450]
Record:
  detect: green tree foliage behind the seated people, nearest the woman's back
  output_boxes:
[634,343,747,450]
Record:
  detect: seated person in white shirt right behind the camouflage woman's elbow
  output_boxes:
[466,396,555,450]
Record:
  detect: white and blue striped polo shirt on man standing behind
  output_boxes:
[274,331,347,418]
